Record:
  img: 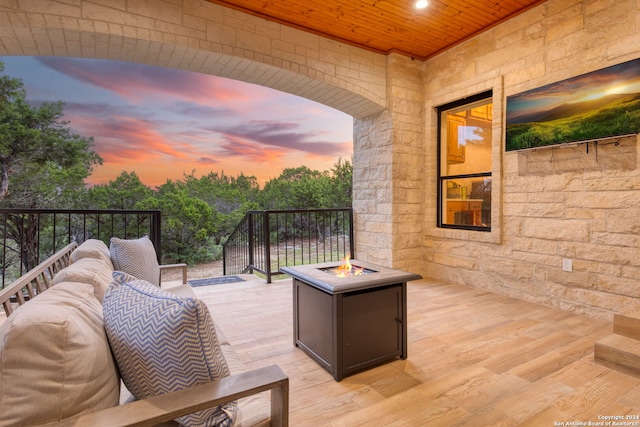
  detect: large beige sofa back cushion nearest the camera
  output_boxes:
[0,282,120,427]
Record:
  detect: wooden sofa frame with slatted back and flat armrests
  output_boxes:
[0,243,289,427]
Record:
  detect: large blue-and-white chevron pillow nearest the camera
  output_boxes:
[103,271,238,427]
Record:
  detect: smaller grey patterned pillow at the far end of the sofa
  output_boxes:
[109,236,160,286]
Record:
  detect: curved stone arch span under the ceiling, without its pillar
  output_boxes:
[0,0,386,118]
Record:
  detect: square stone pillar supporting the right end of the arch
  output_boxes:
[353,55,424,271]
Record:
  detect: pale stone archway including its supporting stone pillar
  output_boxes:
[0,0,424,268]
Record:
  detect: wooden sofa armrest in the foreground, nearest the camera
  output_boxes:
[43,365,289,427]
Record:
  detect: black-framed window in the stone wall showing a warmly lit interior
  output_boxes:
[438,92,493,231]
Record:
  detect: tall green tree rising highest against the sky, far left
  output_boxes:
[0,63,102,208]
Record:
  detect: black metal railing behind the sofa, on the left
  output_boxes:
[0,209,162,289]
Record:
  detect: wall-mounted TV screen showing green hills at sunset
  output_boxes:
[506,59,640,151]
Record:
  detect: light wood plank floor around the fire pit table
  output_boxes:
[194,280,640,427]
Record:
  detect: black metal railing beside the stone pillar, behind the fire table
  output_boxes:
[223,208,355,283]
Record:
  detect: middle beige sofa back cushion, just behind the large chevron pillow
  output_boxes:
[52,258,113,303]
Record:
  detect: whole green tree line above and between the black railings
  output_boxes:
[0,63,353,264]
